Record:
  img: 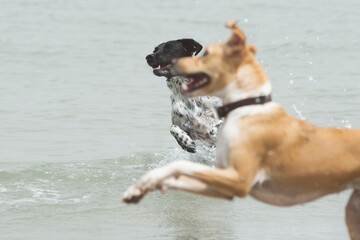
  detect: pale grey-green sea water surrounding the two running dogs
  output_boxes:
[0,0,360,240]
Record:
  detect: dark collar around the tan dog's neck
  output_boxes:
[216,95,271,118]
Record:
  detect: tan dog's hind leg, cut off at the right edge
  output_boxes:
[346,189,360,240]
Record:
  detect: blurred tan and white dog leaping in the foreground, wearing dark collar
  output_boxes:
[123,21,360,239]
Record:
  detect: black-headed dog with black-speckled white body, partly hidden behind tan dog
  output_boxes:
[146,39,222,153]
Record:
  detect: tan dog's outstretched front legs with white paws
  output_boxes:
[123,157,257,203]
